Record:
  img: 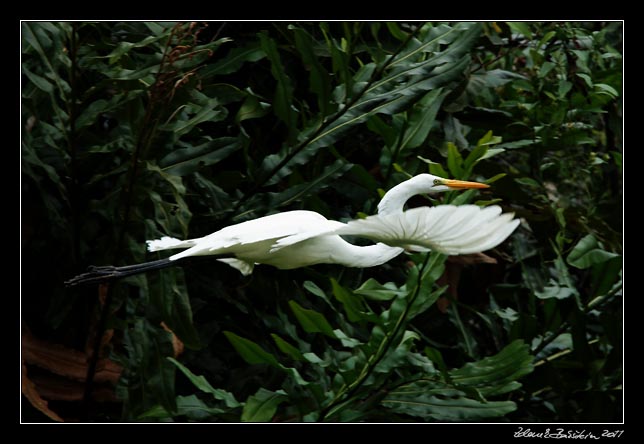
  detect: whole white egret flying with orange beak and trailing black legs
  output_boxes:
[66,174,518,286]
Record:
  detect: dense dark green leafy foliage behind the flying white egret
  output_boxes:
[21,22,623,422]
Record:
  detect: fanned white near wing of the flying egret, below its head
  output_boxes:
[334,205,519,255]
